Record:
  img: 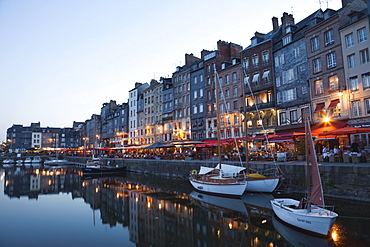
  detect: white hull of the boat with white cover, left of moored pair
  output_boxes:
[189,177,245,196]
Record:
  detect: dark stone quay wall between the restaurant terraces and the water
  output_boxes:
[63,157,370,201]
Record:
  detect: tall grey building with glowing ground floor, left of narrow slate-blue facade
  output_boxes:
[172,54,199,140]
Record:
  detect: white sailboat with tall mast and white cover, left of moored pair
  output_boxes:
[189,69,246,197]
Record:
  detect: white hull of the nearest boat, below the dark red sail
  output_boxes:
[271,198,338,236]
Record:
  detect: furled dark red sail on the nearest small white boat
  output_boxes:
[306,121,325,206]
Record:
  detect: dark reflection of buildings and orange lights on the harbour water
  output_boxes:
[0,167,369,247]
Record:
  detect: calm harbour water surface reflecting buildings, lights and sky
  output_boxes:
[0,167,370,247]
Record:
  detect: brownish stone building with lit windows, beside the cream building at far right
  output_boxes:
[305,9,349,128]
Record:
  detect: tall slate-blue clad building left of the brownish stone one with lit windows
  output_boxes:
[273,10,312,134]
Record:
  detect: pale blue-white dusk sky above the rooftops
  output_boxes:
[0,0,341,141]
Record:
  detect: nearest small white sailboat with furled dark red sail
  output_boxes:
[271,116,338,236]
